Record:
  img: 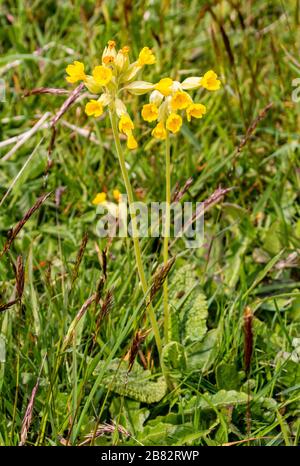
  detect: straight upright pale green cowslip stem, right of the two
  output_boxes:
[163,131,171,344]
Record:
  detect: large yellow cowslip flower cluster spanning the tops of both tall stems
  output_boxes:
[66,40,221,149]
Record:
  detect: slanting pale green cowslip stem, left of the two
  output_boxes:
[109,109,161,356]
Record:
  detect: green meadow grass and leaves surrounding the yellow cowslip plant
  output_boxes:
[0,0,300,445]
